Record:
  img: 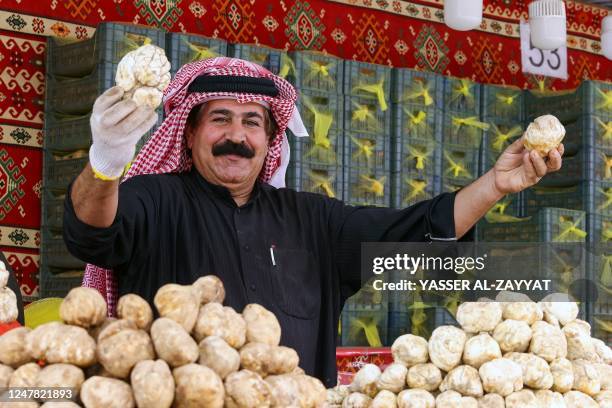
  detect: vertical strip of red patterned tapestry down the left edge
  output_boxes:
[0,30,45,300]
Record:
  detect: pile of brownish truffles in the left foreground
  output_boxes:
[0,274,326,408]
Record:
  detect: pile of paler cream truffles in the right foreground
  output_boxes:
[327,292,612,408]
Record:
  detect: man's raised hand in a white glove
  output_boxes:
[89,86,157,180]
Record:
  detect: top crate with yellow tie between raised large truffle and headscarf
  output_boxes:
[166,33,227,78]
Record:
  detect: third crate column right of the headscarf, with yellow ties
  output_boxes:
[391,68,444,208]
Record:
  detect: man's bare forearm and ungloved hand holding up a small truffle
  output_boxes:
[454,138,563,238]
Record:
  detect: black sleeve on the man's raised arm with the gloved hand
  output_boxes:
[63,177,156,268]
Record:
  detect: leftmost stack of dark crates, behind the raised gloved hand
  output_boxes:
[39,23,165,297]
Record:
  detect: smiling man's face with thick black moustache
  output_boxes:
[187,99,268,187]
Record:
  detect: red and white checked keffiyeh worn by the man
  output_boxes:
[83,57,307,316]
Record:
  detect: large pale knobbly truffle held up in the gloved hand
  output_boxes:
[115,44,170,109]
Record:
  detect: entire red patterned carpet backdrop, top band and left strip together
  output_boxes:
[0,0,612,297]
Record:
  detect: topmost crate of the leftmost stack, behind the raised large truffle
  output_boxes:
[46,23,166,77]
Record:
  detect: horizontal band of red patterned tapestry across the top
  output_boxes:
[0,0,612,89]
